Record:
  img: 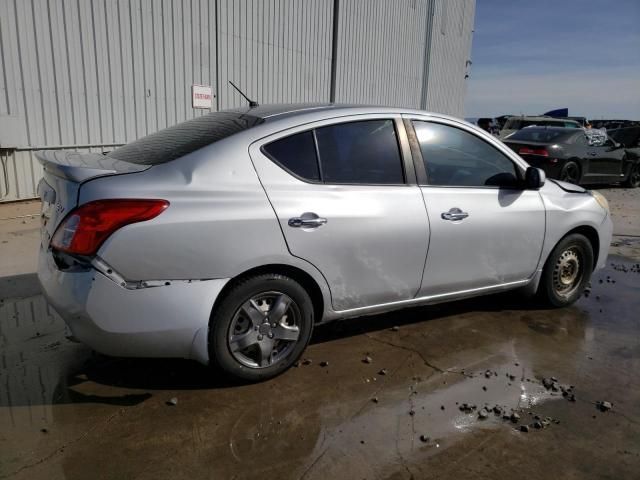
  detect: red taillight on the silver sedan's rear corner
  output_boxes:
[51,199,169,255]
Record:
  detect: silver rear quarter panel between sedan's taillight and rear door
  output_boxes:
[80,141,310,281]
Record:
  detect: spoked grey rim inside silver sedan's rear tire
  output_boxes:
[227,291,302,369]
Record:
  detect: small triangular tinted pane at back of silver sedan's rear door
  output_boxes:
[263,132,320,182]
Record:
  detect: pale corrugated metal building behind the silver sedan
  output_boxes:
[0,0,475,201]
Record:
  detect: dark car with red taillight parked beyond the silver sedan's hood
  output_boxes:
[504,127,640,187]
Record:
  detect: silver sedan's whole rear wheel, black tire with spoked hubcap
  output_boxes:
[209,274,314,382]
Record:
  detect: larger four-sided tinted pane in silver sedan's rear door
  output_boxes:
[316,120,404,184]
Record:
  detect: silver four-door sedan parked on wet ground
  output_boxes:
[39,105,612,381]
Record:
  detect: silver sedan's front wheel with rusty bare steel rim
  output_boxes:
[538,233,593,307]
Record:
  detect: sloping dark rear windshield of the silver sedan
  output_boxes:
[108,112,263,165]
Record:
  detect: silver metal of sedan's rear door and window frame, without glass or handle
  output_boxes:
[250,119,429,310]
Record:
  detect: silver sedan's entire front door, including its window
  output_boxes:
[409,117,545,296]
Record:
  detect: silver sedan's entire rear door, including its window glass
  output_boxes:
[250,116,429,311]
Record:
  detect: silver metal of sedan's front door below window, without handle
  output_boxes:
[419,187,545,296]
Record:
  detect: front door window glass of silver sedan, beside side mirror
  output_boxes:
[413,122,518,186]
